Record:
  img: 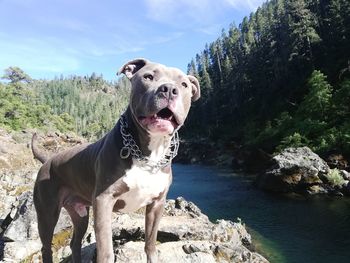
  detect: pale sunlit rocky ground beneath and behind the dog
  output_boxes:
[0,132,268,263]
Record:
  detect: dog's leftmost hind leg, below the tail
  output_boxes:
[34,180,61,263]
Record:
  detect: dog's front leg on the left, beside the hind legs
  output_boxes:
[93,193,115,263]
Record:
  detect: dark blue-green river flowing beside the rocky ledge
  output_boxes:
[168,164,350,263]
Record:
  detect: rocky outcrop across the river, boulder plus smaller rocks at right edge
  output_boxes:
[256,147,350,196]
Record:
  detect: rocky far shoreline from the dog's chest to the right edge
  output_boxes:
[176,140,350,196]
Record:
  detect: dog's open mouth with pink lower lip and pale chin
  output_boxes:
[138,108,180,134]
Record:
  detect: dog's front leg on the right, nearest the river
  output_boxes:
[145,197,165,263]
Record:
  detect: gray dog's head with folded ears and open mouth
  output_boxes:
[119,59,200,135]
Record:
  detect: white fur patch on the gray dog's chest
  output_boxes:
[118,164,170,212]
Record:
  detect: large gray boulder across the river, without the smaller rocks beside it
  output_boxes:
[256,147,330,192]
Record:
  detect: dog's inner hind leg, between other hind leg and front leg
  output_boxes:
[64,206,89,263]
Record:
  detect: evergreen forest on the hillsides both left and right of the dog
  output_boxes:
[0,0,350,157]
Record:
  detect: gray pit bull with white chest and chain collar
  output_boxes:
[32,59,200,263]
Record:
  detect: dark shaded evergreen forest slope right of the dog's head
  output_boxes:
[187,0,350,157]
